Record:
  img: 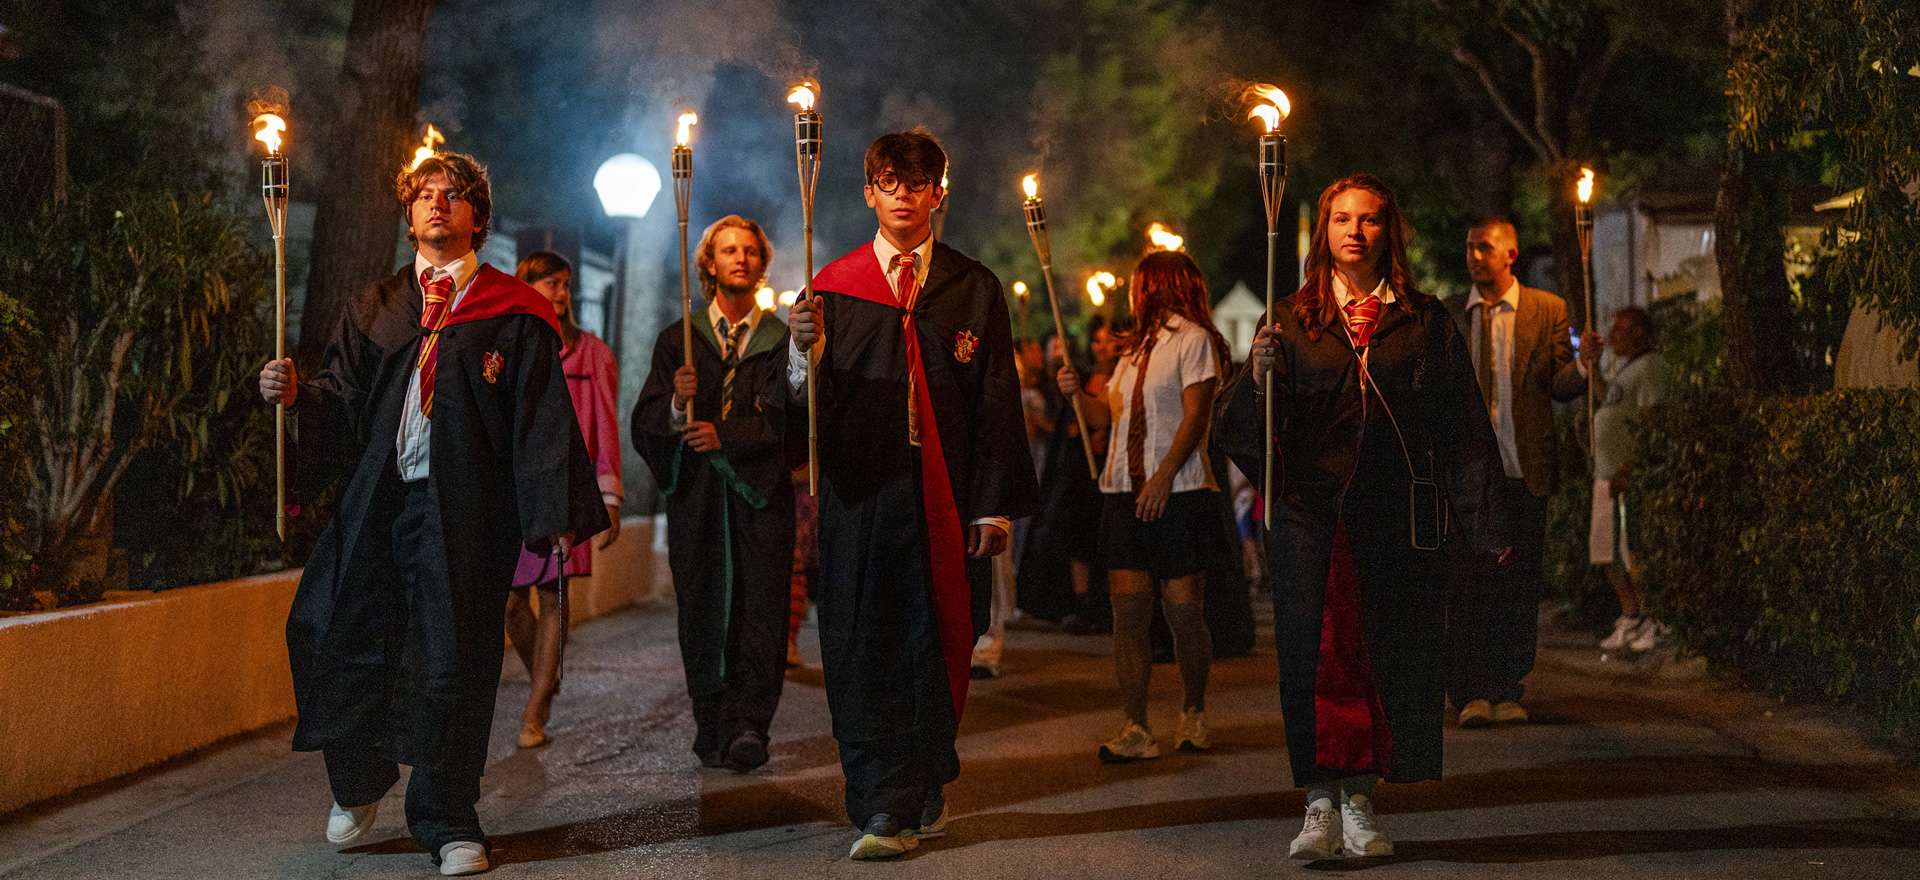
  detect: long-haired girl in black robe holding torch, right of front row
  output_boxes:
[1213,175,1505,861]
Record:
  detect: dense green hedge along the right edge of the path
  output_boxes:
[1630,388,1920,742]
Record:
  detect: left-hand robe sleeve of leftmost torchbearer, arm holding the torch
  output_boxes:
[290,300,378,501]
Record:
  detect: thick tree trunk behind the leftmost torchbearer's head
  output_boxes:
[298,0,434,365]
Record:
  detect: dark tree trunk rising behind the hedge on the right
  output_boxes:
[1713,0,1793,394]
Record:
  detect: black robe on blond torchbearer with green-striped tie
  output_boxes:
[632,309,804,757]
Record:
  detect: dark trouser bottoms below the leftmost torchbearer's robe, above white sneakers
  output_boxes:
[321,747,486,857]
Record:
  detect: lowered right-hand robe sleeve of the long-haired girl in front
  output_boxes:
[1427,306,1511,557]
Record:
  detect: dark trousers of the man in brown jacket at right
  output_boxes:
[1446,475,1548,707]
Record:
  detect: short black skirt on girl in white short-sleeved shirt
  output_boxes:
[1096,488,1221,580]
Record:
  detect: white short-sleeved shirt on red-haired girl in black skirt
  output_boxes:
[1100,315,1219,494]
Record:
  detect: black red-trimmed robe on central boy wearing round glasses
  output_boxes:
[814,242,1039,749]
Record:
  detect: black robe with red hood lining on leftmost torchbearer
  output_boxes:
[286,265,609,774]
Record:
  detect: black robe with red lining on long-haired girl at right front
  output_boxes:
[1213,294,1500,786]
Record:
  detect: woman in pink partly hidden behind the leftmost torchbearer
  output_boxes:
[507,252,624,749]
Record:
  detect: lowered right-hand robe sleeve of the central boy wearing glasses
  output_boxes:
[960,271,1041,525]
